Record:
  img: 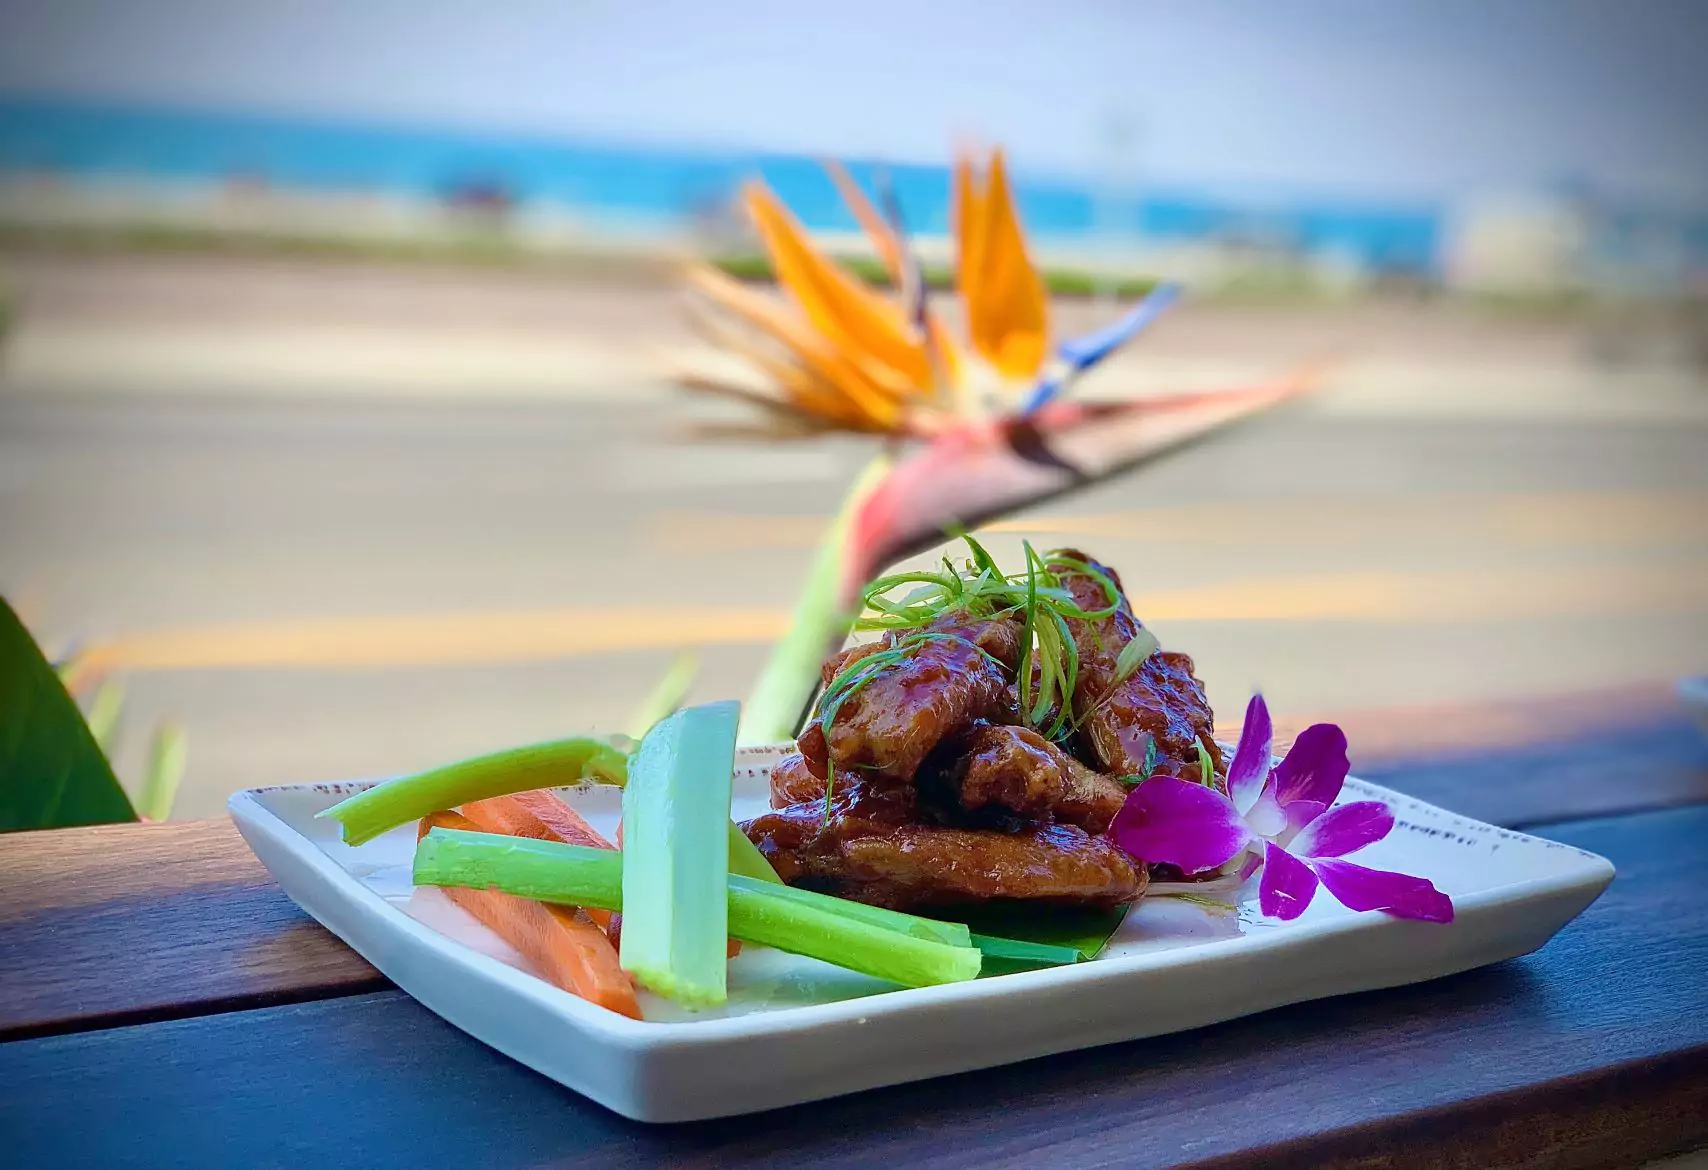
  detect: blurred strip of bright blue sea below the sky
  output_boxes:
[0,96,1442,273]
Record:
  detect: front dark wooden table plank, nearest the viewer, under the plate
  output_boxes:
[0,808,1708,1170]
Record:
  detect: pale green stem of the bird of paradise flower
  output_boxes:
[741,453,895,745]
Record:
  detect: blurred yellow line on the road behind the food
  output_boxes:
[70,560,1708,682]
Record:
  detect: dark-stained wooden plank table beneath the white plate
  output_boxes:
[0,688,1708,1167]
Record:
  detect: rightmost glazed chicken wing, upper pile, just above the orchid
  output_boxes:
[1056,550,1226,775]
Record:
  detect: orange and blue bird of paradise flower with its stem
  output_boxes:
[681,150,1313,741]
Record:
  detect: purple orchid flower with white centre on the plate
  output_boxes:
[1108,695,1454,922]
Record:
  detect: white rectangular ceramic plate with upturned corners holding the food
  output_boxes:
[231,748,1614,1122]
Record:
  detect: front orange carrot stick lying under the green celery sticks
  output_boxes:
[418,813,641,1020]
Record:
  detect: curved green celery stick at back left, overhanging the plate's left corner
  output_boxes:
[319,736,628,845]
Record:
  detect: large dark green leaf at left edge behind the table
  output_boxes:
[0,598,137,832]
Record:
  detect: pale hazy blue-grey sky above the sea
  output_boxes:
[0,0,1708,208]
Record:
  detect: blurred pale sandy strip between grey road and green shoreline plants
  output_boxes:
[0,249,1708,418]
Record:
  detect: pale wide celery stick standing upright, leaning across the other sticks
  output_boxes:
[618,702,741,1006]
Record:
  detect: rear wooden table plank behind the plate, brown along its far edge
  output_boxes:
[0,687,1708,1040]
